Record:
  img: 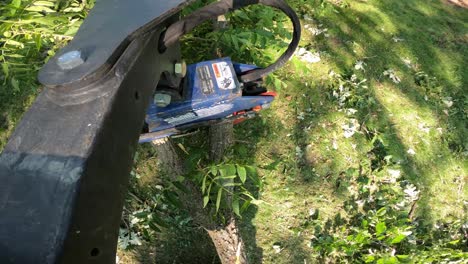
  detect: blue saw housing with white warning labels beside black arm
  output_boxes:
[140,58,274,143]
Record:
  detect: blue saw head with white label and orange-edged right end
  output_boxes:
[139,58,276,143]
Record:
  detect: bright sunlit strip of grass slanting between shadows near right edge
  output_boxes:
[376,83,468,219]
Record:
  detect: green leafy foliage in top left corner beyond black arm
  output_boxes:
[0,0,94,88]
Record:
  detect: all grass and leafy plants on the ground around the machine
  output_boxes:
[0,0,468,263]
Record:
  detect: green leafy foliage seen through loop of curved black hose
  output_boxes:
[183,1,292,90]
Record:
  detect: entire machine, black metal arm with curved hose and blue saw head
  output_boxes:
[0,0,300,264]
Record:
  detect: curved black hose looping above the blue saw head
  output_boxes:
[159,0,301,83]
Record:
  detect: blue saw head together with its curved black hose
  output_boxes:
[139,0,300,143]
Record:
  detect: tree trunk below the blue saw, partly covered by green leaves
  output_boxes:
[152,127,247,264]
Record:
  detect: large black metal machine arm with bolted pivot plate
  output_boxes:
[0,0,300,264]
